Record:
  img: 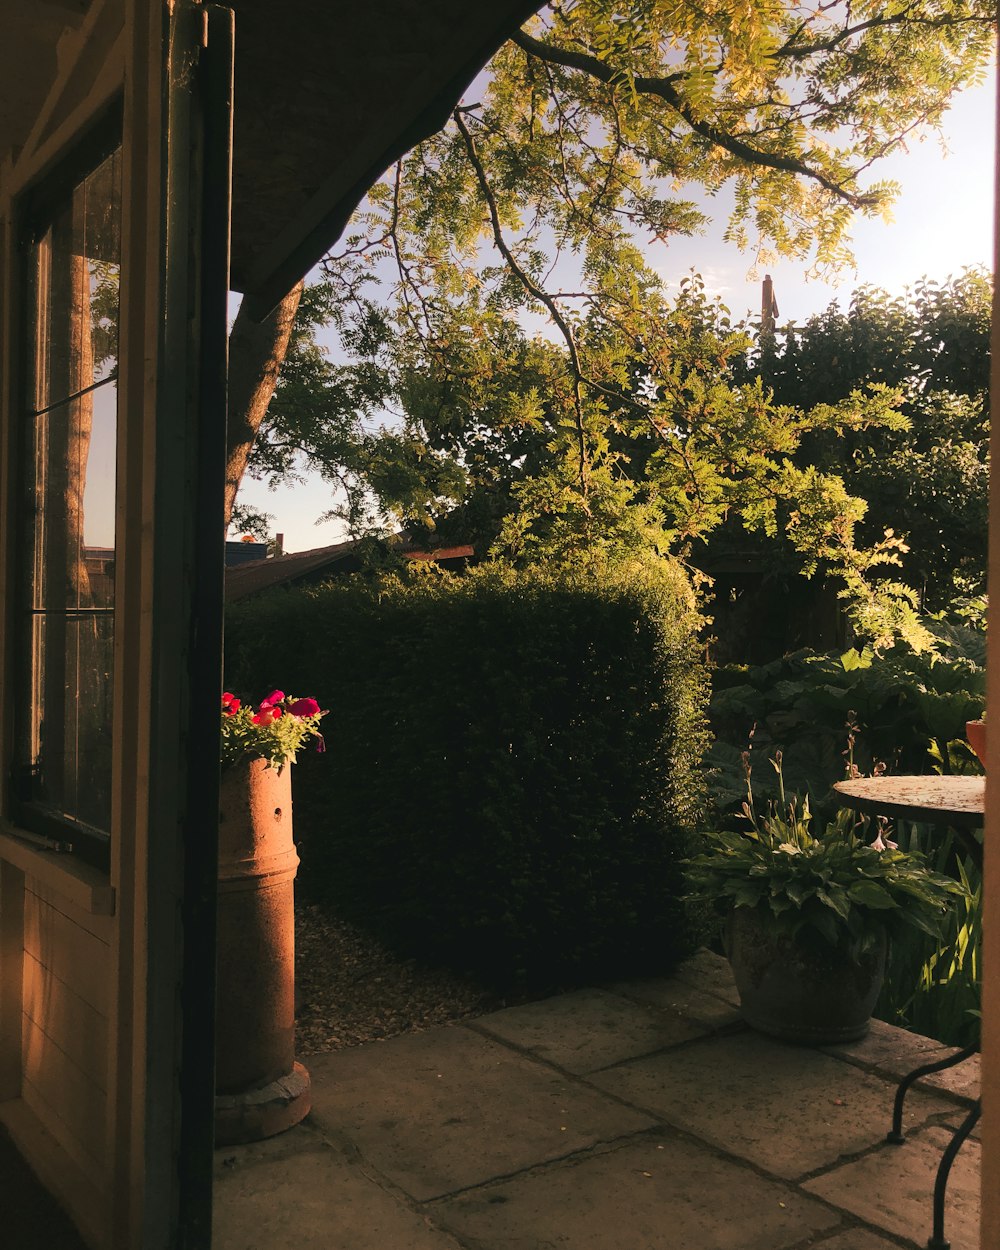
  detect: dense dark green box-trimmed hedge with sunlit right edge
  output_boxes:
[226,564,708,986]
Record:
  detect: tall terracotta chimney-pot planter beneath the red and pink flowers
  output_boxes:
[215,760,310,1145]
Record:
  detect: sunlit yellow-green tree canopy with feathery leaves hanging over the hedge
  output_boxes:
[232,0,993,634]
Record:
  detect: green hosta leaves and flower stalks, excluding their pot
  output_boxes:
[688,755,968,955]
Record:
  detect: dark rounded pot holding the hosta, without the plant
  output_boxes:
[726,908,888,1046]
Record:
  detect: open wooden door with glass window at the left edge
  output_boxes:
[0,0,233,1250]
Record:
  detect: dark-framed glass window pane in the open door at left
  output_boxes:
[20,141,121,846]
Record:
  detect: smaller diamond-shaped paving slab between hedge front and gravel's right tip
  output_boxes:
[474,990,718,1074]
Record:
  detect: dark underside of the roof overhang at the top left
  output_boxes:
[0,0,540,319]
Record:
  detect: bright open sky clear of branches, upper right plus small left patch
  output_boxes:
[230,75,996,551]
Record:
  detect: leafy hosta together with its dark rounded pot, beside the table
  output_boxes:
[688,753,966,1045]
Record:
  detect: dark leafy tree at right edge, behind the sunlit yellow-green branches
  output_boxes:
[758,270,991,610]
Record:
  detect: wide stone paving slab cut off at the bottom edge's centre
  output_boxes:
[434,1134,840,1250]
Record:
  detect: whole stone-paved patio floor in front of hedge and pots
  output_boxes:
[213,951,980,1250]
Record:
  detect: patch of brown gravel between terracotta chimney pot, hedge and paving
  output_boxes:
[295,904,506,1056]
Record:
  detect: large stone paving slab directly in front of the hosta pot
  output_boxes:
[590,1033,954,1179]
